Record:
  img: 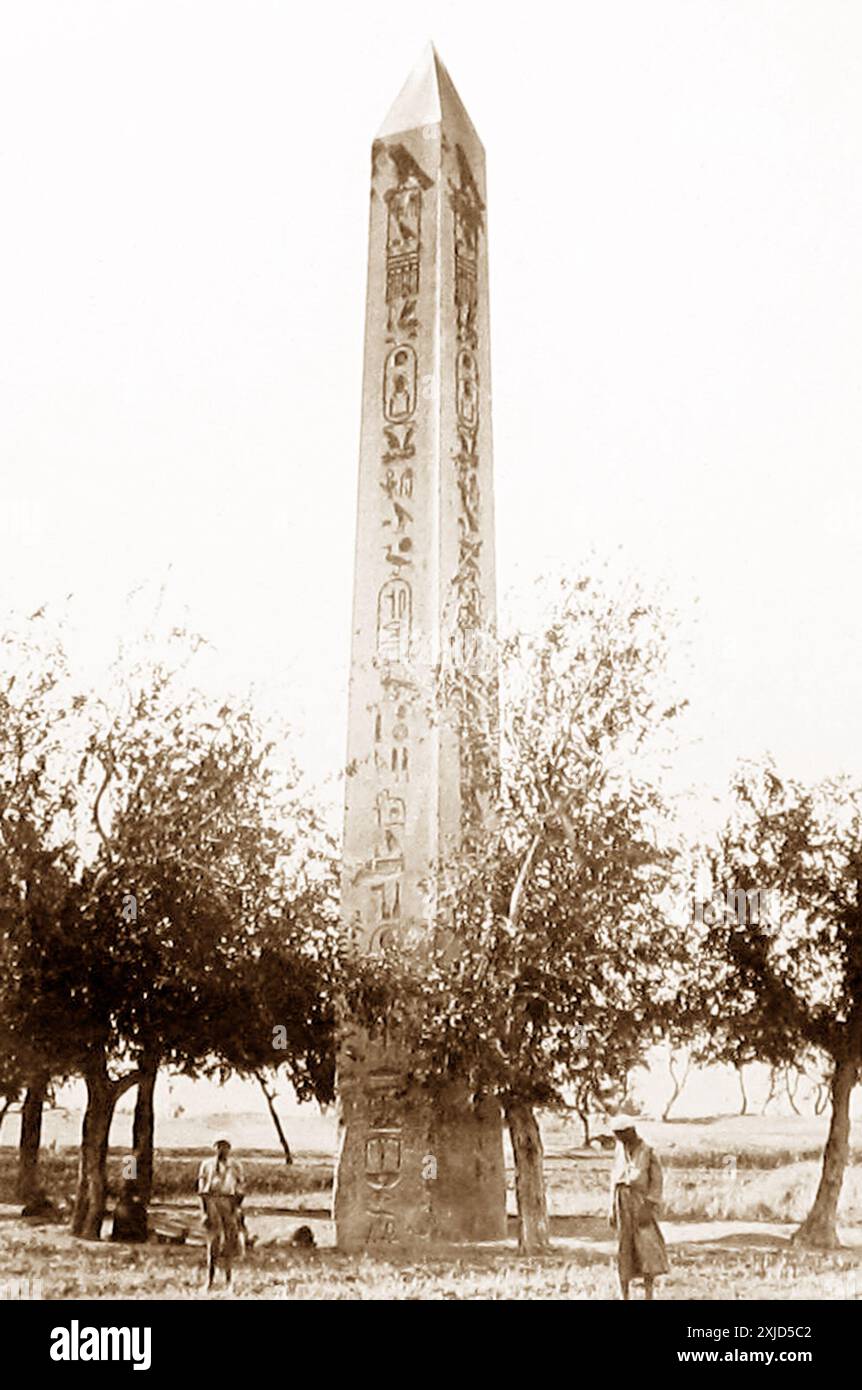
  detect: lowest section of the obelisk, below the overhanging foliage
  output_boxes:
[334,1045,506,1252]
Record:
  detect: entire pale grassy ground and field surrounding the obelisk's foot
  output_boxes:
[0,1116,862,1300]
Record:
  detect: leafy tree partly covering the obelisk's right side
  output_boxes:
[348,569,683,1254]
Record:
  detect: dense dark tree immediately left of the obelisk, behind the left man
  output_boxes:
[64,634,336,1236]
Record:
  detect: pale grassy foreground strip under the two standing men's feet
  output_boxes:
[0,1208,862,1300]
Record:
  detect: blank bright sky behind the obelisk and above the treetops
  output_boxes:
[0,0,862,828]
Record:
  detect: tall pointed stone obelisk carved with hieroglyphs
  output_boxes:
[334,47,506,1250]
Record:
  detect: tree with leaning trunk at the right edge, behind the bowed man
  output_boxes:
[699,763,862,1248]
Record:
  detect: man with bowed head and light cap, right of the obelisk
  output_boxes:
[609,1115,667,1300]
